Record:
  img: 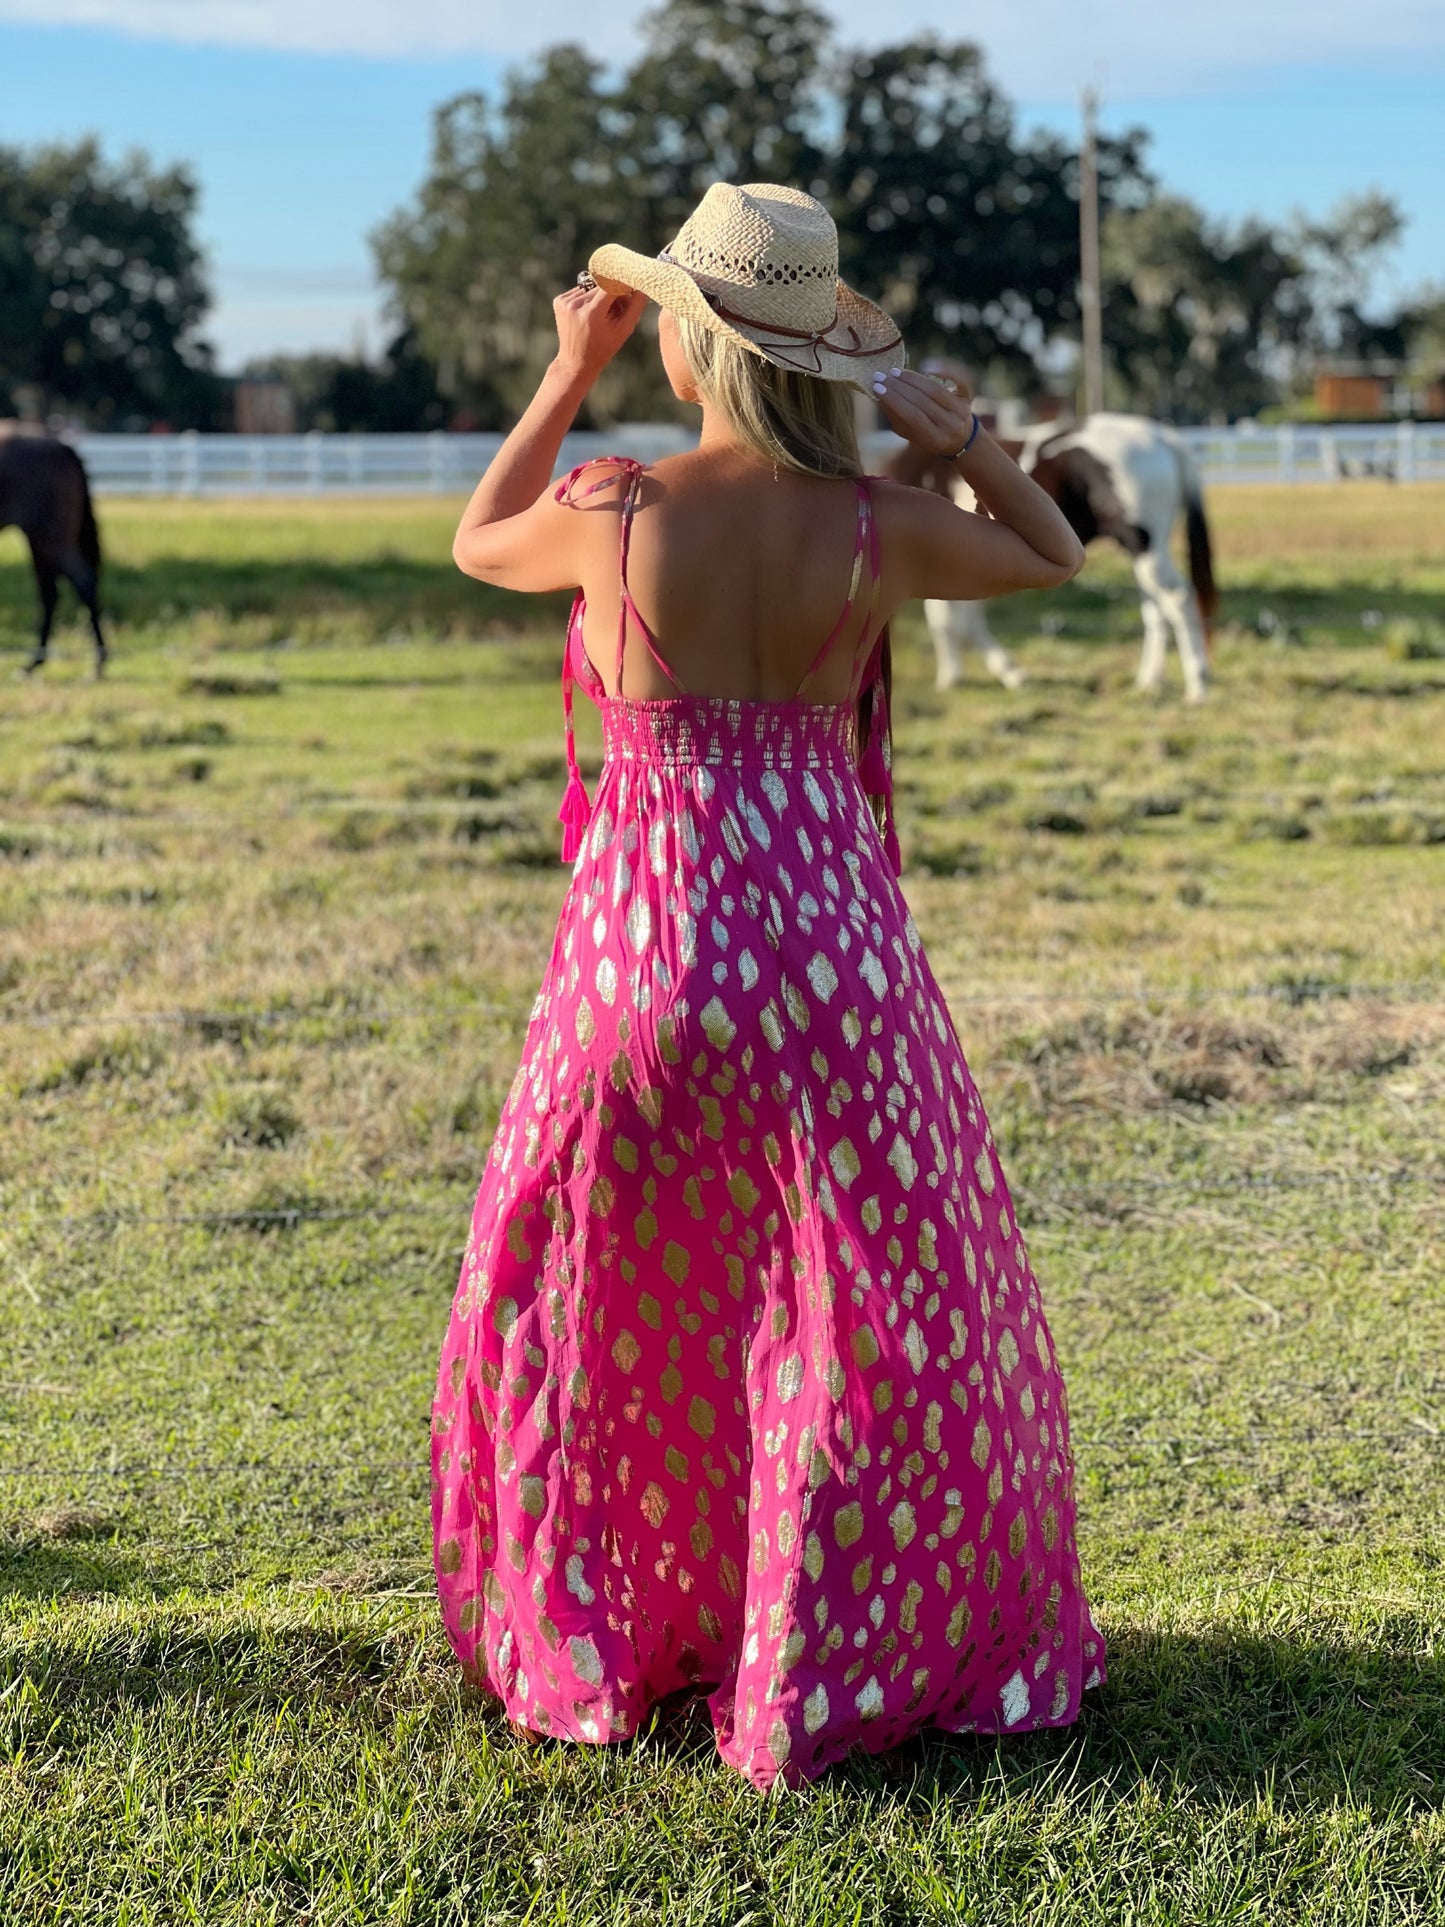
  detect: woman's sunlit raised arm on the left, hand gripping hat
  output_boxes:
[451,287,647,592]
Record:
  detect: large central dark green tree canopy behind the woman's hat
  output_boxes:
[376,0,1146,426]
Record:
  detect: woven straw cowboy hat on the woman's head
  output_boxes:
[588,183,907,391]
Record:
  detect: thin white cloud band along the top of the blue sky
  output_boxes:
[0,0,1445,100]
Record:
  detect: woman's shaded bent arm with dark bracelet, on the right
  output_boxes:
[879,370,1085,601]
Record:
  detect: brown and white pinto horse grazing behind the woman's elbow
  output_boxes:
[886,414,1216,703]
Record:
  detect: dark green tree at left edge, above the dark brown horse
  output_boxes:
[0,141,220,428]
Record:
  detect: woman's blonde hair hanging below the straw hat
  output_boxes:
[674,314,863,476]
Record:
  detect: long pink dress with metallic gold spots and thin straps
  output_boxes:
[434,462,1104,1786]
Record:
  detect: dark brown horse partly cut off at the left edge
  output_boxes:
[0,422,108,676]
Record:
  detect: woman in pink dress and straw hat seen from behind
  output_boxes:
[434,187,1104,1786]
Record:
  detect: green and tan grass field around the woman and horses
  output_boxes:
[0,484,1445,1927]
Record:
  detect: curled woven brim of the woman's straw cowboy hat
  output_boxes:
[588,243,907,393]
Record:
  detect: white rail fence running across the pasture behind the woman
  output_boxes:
[77,422,1445,495]
